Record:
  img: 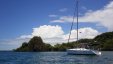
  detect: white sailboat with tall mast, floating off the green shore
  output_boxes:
[67,0,101,55]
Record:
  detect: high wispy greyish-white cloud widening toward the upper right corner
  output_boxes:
[51,1,113,31]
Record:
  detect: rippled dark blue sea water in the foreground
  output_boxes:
[0,52,113,64]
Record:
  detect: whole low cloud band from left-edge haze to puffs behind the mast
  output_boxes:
[0,25,99,50]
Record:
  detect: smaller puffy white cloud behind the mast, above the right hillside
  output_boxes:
[64,27,100,40]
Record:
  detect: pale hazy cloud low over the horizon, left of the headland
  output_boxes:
[0,38,30,50]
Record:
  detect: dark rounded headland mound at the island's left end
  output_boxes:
[15,36,45,52]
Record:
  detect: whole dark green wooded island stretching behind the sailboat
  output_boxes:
[14,32,113,52]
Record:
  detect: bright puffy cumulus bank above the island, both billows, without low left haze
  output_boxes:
[20,25,99,45]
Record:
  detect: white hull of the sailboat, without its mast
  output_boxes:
[67,48,101,55]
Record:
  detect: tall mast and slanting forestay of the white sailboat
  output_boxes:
[68,0,78,43]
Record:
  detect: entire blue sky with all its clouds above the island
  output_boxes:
[0,0,113,50]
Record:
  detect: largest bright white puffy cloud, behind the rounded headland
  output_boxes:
[19,25,64,45]
